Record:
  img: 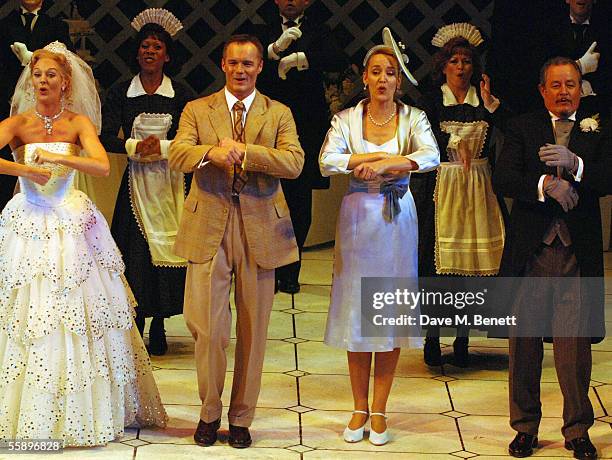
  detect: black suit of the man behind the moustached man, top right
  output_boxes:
[487,0,612,116]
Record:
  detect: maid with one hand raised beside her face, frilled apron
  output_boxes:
[410,23,508,367]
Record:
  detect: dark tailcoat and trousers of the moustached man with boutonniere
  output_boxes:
[493,110,612,440]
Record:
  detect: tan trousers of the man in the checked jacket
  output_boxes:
[184,201,274,427]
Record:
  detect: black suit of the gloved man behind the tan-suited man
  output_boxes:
[257,16,348,282]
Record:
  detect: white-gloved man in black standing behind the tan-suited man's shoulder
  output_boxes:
[257,0,348,294]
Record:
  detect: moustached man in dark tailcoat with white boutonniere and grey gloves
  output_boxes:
[493,58,612,458]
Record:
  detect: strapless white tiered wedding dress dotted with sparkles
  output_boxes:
[0,142,167,446]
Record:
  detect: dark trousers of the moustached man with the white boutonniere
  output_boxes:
[509,239,594,441]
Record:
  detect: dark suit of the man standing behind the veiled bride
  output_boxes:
[0,9,72,209]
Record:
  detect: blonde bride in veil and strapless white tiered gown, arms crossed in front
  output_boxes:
[0,42,167,446]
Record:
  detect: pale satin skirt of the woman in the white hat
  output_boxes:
[325,190,422,352]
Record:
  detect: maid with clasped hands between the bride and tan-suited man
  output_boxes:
[100,8,193,355]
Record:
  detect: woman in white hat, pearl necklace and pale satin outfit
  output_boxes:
[319,29,440,445]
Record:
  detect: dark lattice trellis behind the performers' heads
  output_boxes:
[0,0,494,103]
